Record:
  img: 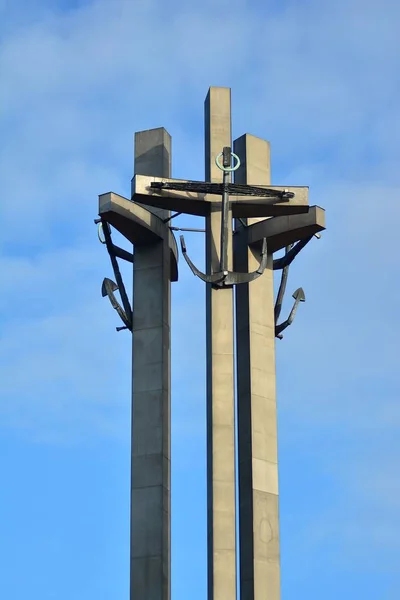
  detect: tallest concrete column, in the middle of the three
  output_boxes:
[205,87,236,600]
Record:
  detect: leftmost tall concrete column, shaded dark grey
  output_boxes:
[130,128,171,600]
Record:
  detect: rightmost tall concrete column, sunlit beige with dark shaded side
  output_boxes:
[234,134,280,600]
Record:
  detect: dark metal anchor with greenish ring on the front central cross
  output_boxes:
[151,146,294,287]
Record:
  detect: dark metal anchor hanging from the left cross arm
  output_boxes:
[95,219,133,331]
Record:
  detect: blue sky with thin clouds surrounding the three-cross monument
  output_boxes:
[0,0,400,600]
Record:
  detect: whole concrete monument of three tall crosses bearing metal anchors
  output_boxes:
[96,87,325,600]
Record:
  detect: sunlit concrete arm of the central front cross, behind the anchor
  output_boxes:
[131,175,309,218]
